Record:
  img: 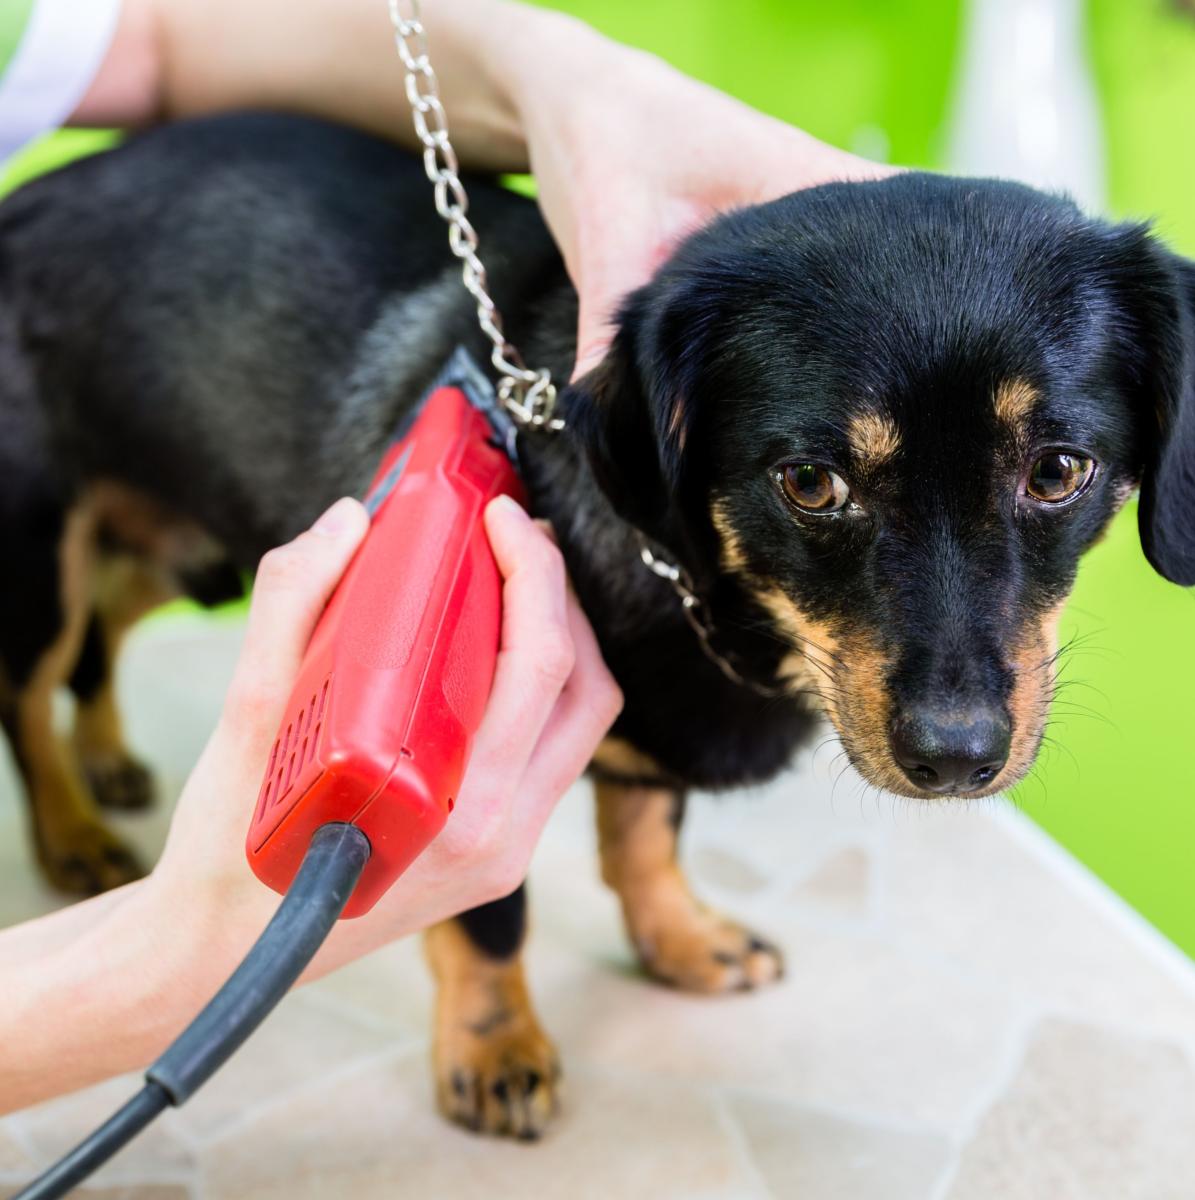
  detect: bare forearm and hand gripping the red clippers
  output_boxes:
[0,492,620,1111]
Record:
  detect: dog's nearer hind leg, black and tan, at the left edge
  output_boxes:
[0,497,142,895]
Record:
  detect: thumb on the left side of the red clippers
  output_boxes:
[224,497,370,737]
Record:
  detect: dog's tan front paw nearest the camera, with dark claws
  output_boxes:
[436,1014,560,1141]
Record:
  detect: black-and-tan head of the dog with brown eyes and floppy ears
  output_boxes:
[571,174,1195,797]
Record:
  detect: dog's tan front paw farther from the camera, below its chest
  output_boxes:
[632,905,785,994]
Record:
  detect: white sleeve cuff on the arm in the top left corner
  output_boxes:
[0,0,121,161]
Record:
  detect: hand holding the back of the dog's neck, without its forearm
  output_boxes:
[511,14,895,377]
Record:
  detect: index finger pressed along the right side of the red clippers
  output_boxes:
[470,497,576,778]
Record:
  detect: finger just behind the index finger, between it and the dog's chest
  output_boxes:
[511,593,623,857]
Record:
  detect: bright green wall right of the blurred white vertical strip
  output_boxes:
[1017,0,1195,955]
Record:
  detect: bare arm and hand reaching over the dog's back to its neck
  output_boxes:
[76,0,888,374]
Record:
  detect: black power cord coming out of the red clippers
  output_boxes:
[13,823,370,1200]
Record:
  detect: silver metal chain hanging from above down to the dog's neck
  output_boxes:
[388,0,564,432]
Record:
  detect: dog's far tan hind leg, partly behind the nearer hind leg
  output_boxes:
[71,557,178,811]
